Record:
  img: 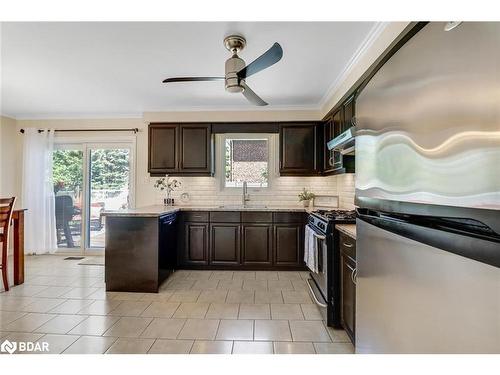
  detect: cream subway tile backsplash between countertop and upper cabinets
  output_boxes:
[142,174,354,209]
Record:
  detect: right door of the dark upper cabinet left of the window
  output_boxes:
[179,124,211,174]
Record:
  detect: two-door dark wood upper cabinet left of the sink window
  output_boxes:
[148,123,213,176]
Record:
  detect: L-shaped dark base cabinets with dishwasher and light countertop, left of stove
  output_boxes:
[105,205,306,292]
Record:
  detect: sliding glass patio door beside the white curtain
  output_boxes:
[53,143,134,252]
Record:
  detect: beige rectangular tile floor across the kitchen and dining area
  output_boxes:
[0,255,354,354]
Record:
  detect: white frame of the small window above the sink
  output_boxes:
[215,133,278,194]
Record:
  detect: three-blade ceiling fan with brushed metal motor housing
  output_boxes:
[163,35,283,106]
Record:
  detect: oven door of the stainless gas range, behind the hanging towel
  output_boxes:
[308,229,328,307]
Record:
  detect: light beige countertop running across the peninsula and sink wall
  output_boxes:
[103,205,310,217]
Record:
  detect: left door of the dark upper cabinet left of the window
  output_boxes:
[148,124,179,175]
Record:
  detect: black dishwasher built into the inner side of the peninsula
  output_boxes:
[158,212,177,285]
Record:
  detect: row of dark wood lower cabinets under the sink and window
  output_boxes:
[178,211,305,270]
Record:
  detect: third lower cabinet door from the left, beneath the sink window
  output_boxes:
[242,224,273,266]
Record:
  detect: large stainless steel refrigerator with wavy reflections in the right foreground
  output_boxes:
[356,22,500,353]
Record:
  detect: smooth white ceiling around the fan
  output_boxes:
[1,22,377,118]
